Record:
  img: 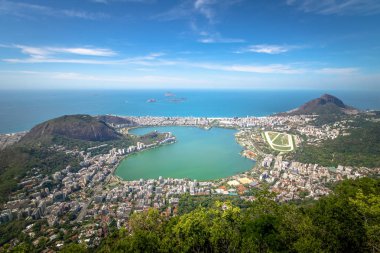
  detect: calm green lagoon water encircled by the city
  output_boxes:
[115,126,254,180]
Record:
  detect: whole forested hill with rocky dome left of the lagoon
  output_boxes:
[0,115,127,203]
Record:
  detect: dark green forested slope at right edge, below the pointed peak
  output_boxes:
[294,120,380,168]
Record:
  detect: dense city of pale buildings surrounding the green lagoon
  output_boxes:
[0,111,380,250]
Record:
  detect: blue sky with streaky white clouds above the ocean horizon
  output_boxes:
[0,0,380,91]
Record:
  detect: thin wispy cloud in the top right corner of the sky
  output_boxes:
[286,0,380,15]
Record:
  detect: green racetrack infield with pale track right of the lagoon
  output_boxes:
[264,131,294,152]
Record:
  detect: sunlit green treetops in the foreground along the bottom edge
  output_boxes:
[55,178,380,252]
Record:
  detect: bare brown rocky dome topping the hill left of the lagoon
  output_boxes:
[21,115,121,141]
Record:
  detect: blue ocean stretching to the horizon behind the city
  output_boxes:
[0,90,380,133]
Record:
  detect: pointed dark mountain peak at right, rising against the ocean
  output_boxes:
[282,94,358,115]
